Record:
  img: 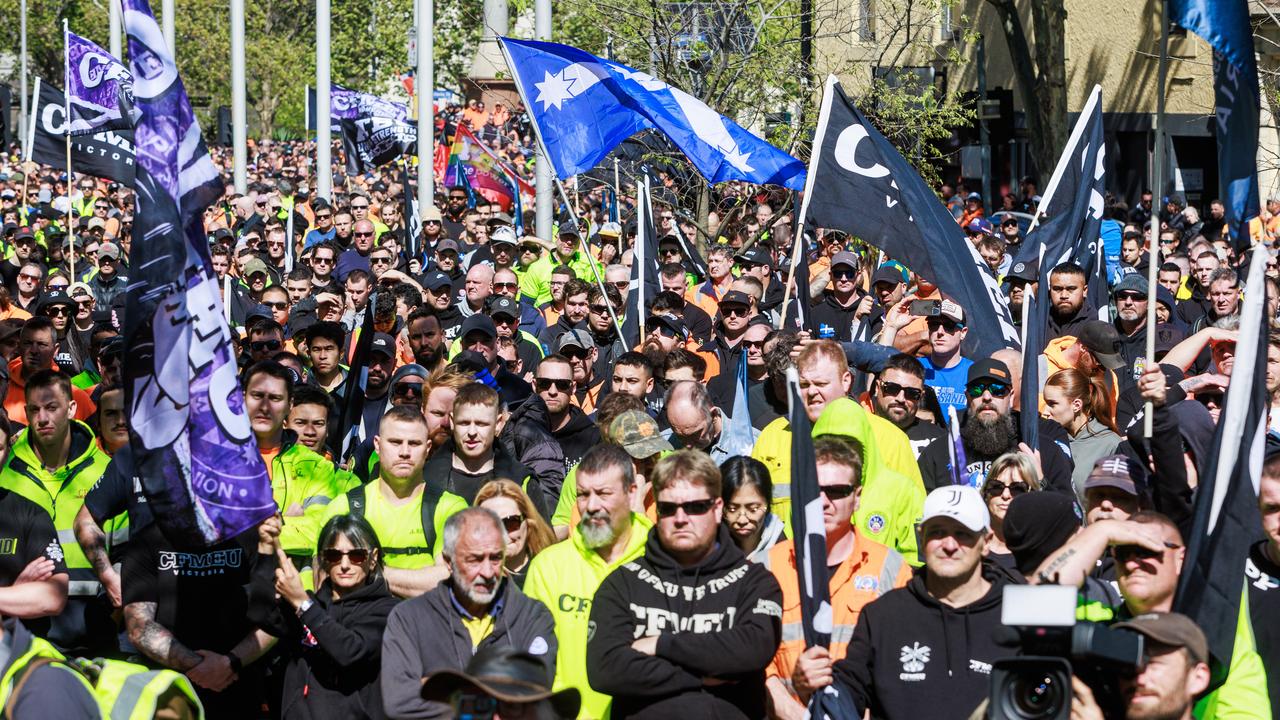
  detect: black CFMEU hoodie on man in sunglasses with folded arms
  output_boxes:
[586,525,782,720]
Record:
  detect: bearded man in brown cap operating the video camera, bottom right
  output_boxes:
[1071,612,1208,720]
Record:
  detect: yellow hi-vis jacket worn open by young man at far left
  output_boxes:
[0,420,115,597]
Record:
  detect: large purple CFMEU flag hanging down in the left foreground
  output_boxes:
[124,0,276,546]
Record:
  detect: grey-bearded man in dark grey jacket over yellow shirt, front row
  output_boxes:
[381,507,558,719]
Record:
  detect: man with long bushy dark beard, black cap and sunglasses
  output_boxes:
[960,357,1075,496]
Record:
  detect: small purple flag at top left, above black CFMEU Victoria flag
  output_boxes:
[65,29,138,135]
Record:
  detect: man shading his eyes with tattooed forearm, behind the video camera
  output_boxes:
[1028,510,1270,720]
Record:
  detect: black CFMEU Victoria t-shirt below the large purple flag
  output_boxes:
[120,523,257,653]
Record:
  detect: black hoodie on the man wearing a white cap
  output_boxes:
[835,562,1018,720]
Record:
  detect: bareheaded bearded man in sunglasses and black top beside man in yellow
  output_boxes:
[870,354,952,492]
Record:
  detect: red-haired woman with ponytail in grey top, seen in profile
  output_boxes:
[1041,368,1124,505]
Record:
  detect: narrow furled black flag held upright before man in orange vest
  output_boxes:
[787,368,861,717]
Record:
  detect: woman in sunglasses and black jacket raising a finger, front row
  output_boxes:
[248,515,398,719]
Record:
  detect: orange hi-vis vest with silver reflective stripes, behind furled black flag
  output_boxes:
[764,529,911,689]
